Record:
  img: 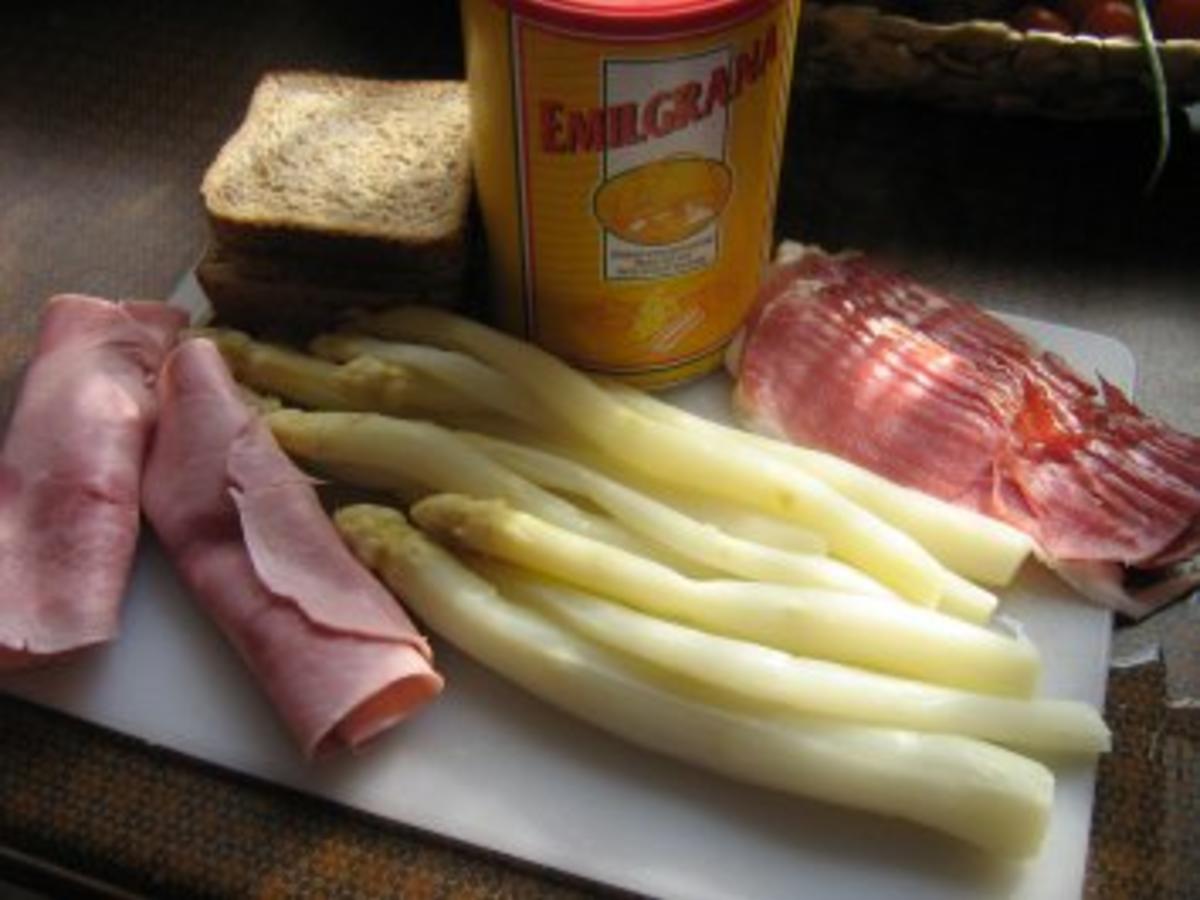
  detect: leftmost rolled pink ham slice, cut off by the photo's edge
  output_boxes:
[0,294,184,668]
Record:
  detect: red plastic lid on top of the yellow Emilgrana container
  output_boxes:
[494,0,779,40]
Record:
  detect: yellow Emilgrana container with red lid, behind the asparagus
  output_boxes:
[462,0,800,388]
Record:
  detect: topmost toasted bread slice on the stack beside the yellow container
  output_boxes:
[200,72,470,264]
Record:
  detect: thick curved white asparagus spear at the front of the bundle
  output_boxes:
[336,506,1054,857]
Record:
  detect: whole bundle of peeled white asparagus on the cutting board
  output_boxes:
[206,307,1109,857]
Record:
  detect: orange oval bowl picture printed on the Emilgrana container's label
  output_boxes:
[594,156,733,246]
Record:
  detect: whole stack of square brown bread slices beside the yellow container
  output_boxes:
[197,72,472,332]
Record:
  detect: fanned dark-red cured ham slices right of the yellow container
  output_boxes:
[731,246,1200,614]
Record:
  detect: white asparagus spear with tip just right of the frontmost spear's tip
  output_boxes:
[412,494,1040,696]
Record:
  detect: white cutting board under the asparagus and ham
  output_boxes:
[2,282,1134,900]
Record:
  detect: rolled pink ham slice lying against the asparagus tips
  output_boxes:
[143,338,442,756]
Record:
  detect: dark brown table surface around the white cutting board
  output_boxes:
[0,0,1200,898]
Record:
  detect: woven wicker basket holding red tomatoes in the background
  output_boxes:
[797,1,1200,119]
